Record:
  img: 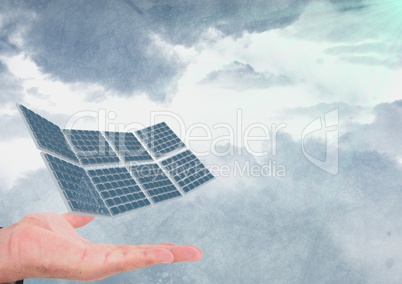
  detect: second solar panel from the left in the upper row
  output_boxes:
[64,129,120,166]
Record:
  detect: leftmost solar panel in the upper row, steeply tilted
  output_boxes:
[20,105,78,162]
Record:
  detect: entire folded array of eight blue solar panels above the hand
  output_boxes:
[19,105,214,216]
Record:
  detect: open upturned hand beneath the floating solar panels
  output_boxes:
[0,213,202,283]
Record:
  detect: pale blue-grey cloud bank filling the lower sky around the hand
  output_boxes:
[0,127,402,283]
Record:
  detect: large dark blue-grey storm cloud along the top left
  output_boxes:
[3,0,307,100]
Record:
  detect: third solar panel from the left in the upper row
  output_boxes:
[105,131,153,162]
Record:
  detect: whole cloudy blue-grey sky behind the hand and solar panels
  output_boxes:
[0,0,402,283]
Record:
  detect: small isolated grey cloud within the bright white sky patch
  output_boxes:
[200,61,294,91]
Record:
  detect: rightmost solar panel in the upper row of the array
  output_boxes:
[136,122,185,158]
